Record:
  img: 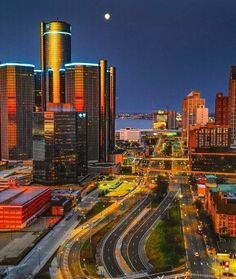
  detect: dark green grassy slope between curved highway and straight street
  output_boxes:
[145,201,185,271]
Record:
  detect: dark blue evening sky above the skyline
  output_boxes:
[0,0,236,112]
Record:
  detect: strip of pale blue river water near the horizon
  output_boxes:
[116,119,152,130]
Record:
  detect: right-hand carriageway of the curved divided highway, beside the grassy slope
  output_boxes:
[122,187,178,272]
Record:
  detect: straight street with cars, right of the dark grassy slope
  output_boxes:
[181,186,216,278]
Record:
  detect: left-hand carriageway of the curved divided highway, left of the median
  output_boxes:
[101,195,150,277]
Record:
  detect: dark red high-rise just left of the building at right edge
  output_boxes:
[215,92,229,125]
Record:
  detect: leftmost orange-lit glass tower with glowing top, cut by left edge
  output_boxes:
[0,63,34,160]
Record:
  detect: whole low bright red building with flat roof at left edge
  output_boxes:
[0,187,51,229]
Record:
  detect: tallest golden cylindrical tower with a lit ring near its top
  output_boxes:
[40,21,71,109]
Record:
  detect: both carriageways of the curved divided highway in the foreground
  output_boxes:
[102,187,178,277]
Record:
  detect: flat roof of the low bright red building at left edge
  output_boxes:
[0,187,49,205]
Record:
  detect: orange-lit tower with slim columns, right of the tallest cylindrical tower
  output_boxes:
[65,60,115,162]
